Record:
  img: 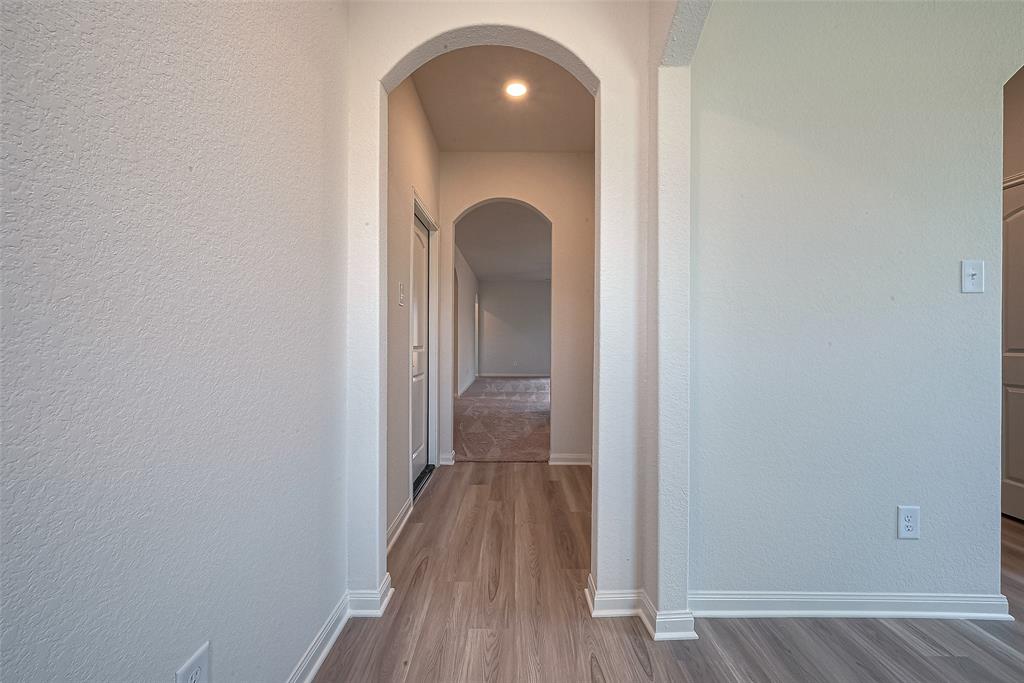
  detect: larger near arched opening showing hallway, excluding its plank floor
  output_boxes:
[384,37,597,561]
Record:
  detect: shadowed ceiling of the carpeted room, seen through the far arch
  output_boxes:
[455,200,551,280]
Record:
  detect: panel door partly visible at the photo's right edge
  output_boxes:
[1002,183,1024,519]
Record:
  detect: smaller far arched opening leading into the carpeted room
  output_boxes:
[453,199,555,463]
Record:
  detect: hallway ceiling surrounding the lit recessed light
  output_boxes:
[411,45,594,152]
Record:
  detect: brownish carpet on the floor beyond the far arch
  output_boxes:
[455,377,551,463]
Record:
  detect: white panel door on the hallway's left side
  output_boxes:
[410,218,430,480]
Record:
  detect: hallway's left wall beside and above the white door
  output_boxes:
[387,79,439,526]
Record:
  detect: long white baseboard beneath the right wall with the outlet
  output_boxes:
[689,591,1013,622]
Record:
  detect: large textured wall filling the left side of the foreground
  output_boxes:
[0,2,346,683]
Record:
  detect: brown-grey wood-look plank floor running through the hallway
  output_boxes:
[316,463,1024,683]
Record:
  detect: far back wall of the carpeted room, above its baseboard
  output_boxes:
[480,280,551,376]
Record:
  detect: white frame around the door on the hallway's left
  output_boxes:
[408,192,440,501]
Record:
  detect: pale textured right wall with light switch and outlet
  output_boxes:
[691,2,1024,594]
